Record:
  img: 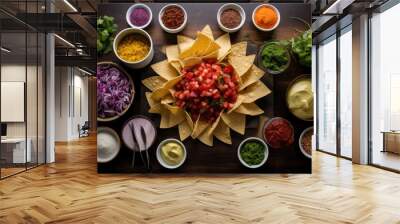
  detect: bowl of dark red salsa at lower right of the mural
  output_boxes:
[263,117,294,149]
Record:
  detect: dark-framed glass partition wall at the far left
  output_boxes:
[0,1,46,179]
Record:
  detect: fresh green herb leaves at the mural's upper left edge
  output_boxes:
[97,16,118,54]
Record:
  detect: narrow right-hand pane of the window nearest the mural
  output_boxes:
[340,27,353,158]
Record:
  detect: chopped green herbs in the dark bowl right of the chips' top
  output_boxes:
[261,42,290,72]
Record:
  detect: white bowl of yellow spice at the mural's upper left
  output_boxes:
[113,28,154,69]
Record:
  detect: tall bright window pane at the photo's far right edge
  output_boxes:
[370,4,400,170]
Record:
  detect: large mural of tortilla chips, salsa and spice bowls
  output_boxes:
[97,3,313,173]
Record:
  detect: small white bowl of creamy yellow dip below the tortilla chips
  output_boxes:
[157,138,186,169]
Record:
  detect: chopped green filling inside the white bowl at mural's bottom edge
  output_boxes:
[240,140,265,166]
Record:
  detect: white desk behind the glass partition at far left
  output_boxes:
[1,138,32,163]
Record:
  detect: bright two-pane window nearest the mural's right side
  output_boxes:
[316,25,352,159]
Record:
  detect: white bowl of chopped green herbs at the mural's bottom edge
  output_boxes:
[238,137,269,169]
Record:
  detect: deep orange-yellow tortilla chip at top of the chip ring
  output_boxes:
[179,32,219,59]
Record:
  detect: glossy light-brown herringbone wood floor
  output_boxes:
[0,138,400,224]
